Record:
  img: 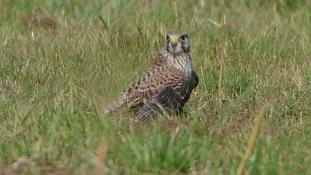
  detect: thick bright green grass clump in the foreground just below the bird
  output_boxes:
[120,127,210,173]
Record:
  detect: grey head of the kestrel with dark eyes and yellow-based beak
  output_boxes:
[166,33,190,56]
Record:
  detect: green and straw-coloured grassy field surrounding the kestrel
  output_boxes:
[0,0,311,175]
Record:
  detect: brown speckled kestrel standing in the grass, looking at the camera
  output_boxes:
[104,32,199,122]
